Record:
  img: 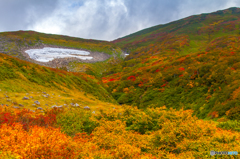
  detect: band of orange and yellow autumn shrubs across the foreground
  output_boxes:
[0,106,240,159]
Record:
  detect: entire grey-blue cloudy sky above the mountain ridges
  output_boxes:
[0,0,240,41]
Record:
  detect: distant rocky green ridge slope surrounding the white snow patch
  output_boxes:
[0,31,123,71]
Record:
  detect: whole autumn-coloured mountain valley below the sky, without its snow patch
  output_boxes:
[0,8,240,159]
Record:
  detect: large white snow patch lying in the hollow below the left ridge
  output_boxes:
[25,47,93,62]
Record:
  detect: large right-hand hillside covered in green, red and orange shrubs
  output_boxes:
[103,8,240,119]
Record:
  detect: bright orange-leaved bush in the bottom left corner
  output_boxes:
[0,123,77,159]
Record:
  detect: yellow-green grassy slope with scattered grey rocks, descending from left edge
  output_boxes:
[0,54,119,112]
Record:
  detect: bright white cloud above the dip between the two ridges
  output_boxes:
[29,0,127,40]
